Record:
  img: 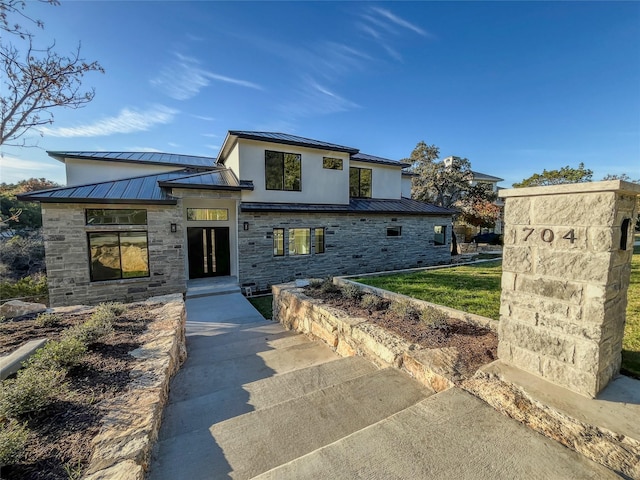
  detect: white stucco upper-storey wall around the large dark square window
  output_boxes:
[238,140,349,204]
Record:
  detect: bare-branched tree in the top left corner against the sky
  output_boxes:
[0,0,104,146]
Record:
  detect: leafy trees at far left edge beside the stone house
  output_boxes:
[0,178,60,230]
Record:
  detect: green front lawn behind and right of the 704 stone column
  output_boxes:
[356,253,640,378]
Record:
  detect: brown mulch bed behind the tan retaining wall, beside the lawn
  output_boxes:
[305,288,498,375]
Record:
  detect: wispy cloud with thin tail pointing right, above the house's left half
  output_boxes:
[151,53,263,100]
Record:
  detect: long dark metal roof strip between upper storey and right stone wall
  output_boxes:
[240,197,456,216]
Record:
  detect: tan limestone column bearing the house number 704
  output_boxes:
[498,180,640,397]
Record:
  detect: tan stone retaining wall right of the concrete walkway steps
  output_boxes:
[272,283,495,392]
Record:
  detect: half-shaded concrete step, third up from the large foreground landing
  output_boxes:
[170,339,340,403]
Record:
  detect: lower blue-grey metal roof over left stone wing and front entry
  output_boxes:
[18,169,252,205]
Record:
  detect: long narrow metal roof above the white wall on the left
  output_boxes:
[47,151,215,172]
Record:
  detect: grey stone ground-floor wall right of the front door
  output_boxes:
[238,212,451,290]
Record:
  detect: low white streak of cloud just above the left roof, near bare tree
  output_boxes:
[40,105,178,138]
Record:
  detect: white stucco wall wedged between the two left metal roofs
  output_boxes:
[65,158,183,186]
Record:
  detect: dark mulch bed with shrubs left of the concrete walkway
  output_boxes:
[0,305,154,480]
